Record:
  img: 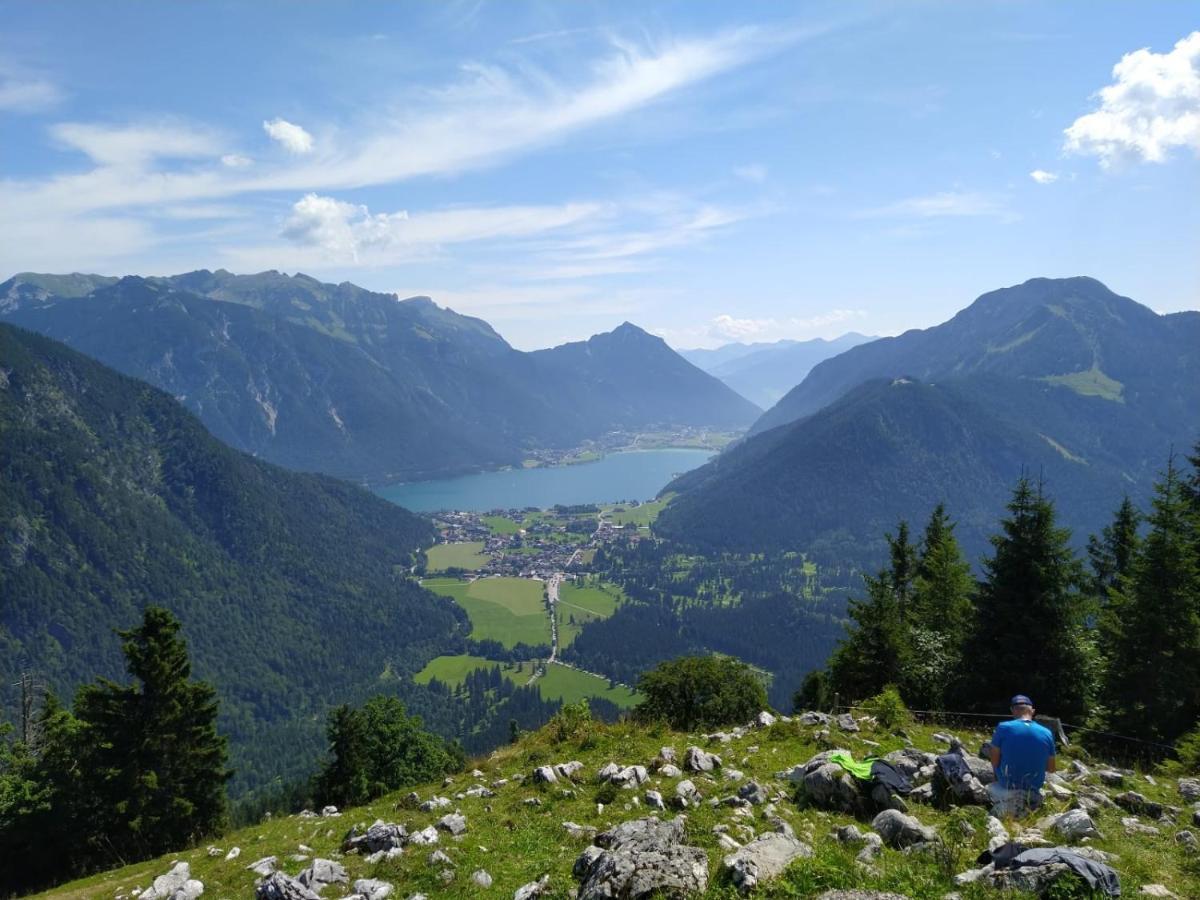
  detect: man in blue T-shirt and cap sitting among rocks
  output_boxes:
[988,694,1055,817]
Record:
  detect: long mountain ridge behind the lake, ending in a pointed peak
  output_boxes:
[0,270,760,481]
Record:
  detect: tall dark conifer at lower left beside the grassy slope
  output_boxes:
[76,606,230,860]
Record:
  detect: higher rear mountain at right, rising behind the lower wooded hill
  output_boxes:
[751,277,1200,433]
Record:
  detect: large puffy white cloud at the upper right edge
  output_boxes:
[1063,31,1200,168]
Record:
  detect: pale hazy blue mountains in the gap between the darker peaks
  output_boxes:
[679,331,875,409]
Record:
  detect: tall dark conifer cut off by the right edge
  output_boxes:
[1103,458,1200,742]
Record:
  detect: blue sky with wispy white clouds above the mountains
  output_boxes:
[0,0,1200,348]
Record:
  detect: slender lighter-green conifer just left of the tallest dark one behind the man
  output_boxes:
[901,504,974,709]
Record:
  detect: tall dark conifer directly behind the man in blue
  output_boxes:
[964,476,1092,719]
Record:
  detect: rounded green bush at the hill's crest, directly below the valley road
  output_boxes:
[634,656,767,731]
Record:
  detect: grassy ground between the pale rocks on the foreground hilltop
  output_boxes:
[42,719,1200,900]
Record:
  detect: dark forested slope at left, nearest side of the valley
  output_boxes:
[0,325,468,793]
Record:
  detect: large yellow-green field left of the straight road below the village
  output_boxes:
[421,578,550,647]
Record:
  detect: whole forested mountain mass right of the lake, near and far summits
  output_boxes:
[656,278,1200,562]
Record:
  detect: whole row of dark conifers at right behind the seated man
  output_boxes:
[796,448,1200,745]
